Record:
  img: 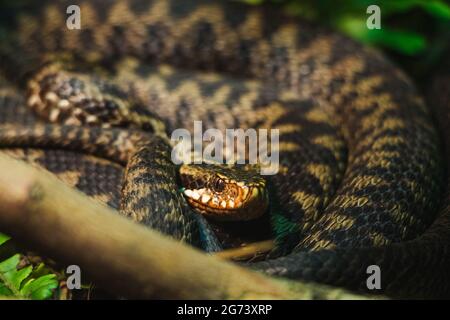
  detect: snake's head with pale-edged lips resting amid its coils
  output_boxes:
[180,164,269,221]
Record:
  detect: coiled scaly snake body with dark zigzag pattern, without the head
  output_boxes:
[0,0,450,298]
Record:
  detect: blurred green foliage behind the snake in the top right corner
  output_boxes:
[244,0,450,83]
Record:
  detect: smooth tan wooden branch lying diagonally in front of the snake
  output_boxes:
[0,153,368,299]
